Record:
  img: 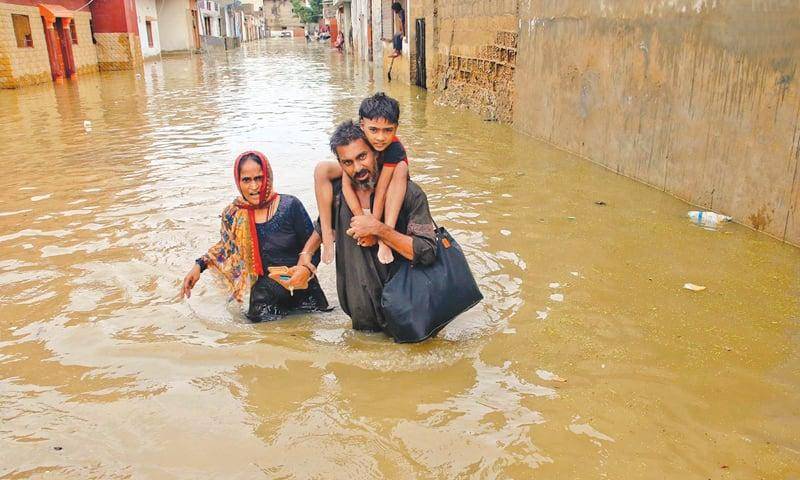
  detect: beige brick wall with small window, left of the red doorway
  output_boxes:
[0,3,52,88]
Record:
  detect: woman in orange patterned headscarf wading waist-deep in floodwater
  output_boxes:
[181,152,328,322]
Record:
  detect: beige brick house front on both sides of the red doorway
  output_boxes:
[0,3,97,88]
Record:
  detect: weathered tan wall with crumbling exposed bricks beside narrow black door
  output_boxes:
[422,0,518,122]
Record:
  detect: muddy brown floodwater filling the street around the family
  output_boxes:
[0,39,800,479]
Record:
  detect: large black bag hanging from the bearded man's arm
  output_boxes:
[381,227,483,343]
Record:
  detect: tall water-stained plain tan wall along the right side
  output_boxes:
[513,0,800,245]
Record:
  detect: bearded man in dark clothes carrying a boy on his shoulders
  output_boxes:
[303,121,436,331]
